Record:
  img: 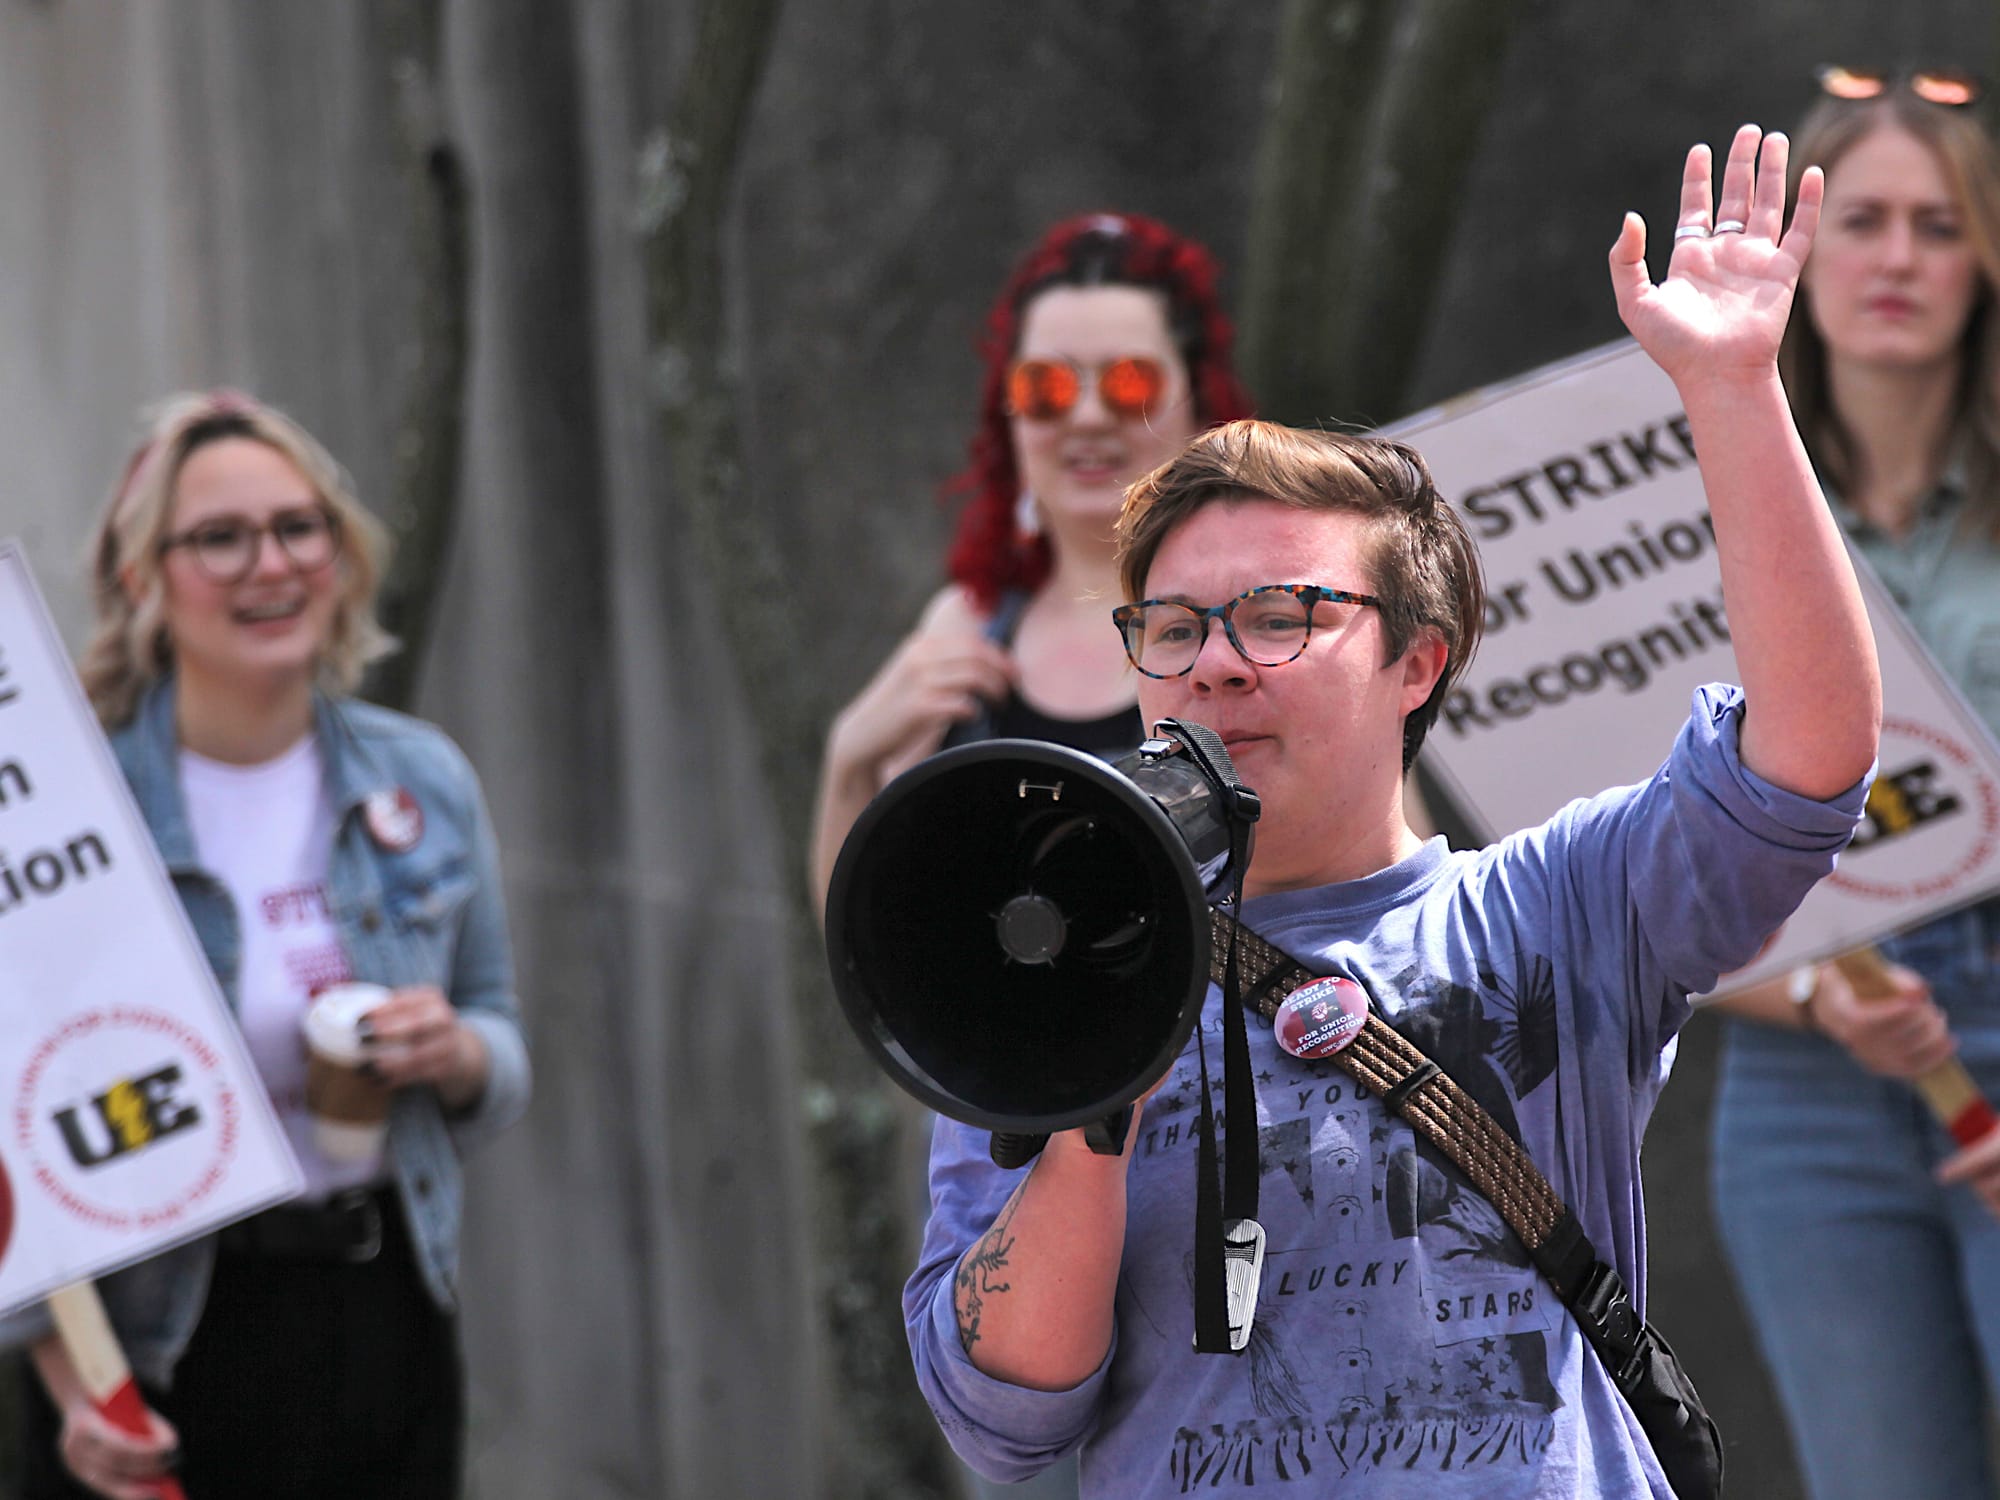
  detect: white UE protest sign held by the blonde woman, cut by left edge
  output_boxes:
[0,542,304,1310]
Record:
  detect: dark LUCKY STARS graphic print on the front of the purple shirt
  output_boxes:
[1130,956,1562,1494]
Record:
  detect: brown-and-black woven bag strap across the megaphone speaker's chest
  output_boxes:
[1210,908,1722,1500]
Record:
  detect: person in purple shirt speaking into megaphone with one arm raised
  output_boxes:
[900,126,1880,1500]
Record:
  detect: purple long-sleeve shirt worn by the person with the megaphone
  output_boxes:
[904,688,1866,1500]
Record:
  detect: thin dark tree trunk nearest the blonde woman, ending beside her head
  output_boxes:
[368,0,472,708]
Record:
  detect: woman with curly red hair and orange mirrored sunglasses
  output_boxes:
[812,214,1250,902]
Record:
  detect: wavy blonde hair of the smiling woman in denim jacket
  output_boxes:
[78,390,396,728]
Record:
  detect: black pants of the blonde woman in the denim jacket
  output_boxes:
[20,1192,464,1500]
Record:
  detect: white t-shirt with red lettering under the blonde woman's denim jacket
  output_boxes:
[180,734,382,1198]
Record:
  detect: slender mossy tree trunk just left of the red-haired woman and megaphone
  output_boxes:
[638,0,950,1500]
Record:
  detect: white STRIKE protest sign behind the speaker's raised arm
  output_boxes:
[1390,340,2000,988]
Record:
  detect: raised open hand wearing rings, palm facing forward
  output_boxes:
[1610,126,1826,384]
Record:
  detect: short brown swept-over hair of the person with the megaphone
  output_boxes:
[1118,420,1486,770]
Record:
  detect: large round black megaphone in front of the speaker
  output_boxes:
[826,720,1256,1136]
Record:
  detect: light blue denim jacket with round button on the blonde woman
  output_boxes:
[0,678,530,1386]
